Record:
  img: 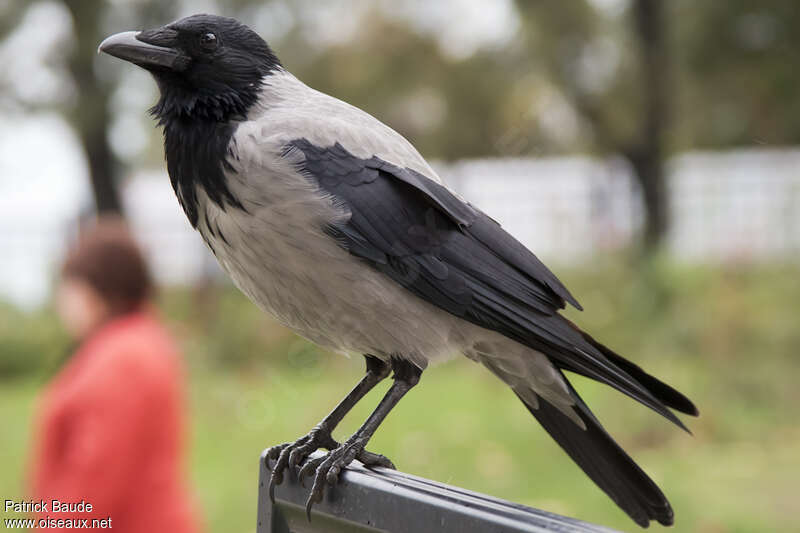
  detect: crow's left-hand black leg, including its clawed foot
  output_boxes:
[265,355,394,501]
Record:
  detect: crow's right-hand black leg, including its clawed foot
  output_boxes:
[298,359,422,520]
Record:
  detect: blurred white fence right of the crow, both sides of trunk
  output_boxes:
[441,150,800,261]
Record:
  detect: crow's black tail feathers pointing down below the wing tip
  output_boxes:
[520,377,674,527]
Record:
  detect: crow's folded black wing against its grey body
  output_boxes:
[287,139,685,429]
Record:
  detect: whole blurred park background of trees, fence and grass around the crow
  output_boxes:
[0,0,800,533]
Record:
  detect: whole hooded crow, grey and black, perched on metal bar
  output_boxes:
[100,15,697,527]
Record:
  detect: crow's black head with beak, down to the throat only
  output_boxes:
[99,15,280,122]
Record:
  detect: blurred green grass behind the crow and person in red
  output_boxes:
[0,263,800,533]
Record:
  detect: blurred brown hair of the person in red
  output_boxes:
[61,217,153,315]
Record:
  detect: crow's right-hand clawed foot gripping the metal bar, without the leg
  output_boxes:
[297,435,394,520]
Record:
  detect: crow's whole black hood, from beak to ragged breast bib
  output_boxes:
[99,15,280,227]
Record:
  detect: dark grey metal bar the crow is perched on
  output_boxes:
[257,452,612,533]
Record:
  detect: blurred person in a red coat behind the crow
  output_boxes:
[30,219,199,533]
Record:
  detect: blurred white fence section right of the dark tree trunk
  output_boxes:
[669,150,800,261]
